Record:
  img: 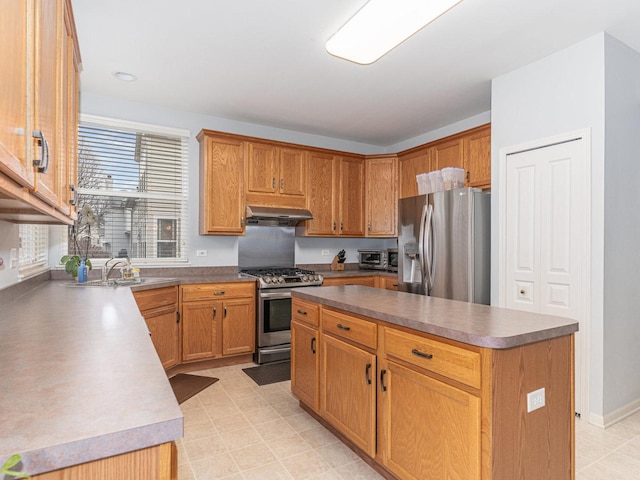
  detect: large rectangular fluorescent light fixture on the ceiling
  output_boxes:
[326,0,462,65]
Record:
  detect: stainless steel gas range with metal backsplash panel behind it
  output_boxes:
[238,207,324,364]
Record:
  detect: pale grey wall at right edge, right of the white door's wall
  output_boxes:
[603,37,640,414]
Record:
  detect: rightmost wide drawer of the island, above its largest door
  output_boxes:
[384,327,480,388]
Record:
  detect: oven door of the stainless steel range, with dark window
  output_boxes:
[257,288,291,347]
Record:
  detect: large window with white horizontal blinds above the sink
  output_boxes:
[68,115,189,264]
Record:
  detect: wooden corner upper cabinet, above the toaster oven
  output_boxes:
[365,155,398,237]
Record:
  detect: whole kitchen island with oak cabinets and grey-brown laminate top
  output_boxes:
[291,286,578,480]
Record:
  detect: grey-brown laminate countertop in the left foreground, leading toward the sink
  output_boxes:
[0,281,183,475]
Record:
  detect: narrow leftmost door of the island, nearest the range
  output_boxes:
[291,319,320,411]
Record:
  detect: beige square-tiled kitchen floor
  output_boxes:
[177,365,640,480]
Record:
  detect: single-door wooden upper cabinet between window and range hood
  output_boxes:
[197,130,245,235]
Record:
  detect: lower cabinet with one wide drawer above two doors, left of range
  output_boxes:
[181,282,256,362]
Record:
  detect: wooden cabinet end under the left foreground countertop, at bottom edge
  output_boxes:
[31,442,178,480]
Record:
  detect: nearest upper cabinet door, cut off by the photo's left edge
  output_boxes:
[0,0,34,188]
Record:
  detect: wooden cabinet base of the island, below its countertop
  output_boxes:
[292,302,575,480]
